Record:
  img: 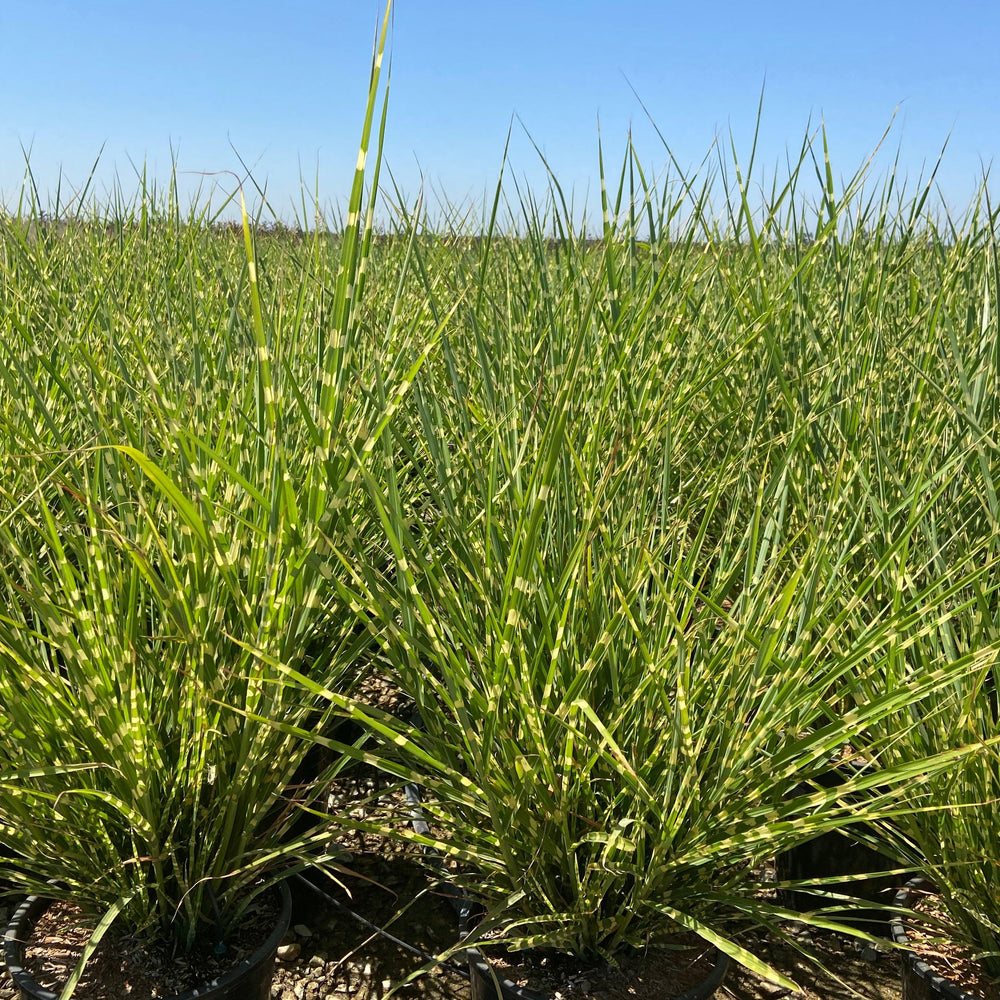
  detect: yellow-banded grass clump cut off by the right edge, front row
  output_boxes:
[852,332,1000,986]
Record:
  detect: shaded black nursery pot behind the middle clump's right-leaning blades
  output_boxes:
[774,764,899,937]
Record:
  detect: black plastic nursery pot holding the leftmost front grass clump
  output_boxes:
[4,882,292,1000]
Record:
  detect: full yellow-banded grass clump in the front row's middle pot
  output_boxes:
[312,213,1000,997]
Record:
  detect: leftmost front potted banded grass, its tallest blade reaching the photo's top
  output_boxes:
[0,6,419,1000]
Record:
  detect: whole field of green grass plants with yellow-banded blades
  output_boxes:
[0,21,1000,981]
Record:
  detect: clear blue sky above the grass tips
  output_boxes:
[0,0,1000,226]
